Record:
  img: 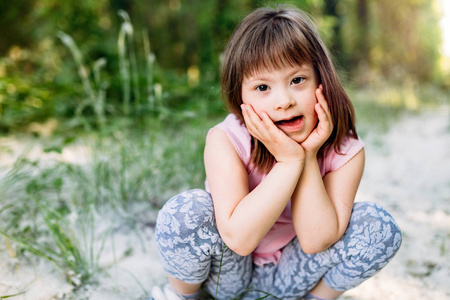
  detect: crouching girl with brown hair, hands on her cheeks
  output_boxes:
[153,7,402,299]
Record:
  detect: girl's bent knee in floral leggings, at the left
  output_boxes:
[155,190,223,283]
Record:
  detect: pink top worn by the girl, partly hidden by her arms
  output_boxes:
[205,114,364,265]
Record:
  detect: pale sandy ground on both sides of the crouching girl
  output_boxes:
[0,108,450,300]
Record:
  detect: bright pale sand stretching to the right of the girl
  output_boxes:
[344,109,450,300]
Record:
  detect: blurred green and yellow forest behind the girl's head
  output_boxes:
[0,0,450,134]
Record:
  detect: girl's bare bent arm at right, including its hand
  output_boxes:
[291,88,364,253]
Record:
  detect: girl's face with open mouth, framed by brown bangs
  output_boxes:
[242,64,319,143]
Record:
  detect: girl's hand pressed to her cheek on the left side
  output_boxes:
[241,104,305,162]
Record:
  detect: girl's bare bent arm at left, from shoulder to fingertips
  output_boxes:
[204,107,304,256]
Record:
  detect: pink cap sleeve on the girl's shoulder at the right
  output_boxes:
[319,136,364,177]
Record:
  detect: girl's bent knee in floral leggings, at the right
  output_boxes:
[324,202,402,291]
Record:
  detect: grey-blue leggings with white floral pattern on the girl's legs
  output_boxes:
[156,190,402,299]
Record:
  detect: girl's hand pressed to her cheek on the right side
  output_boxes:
[301,85,333,157]
